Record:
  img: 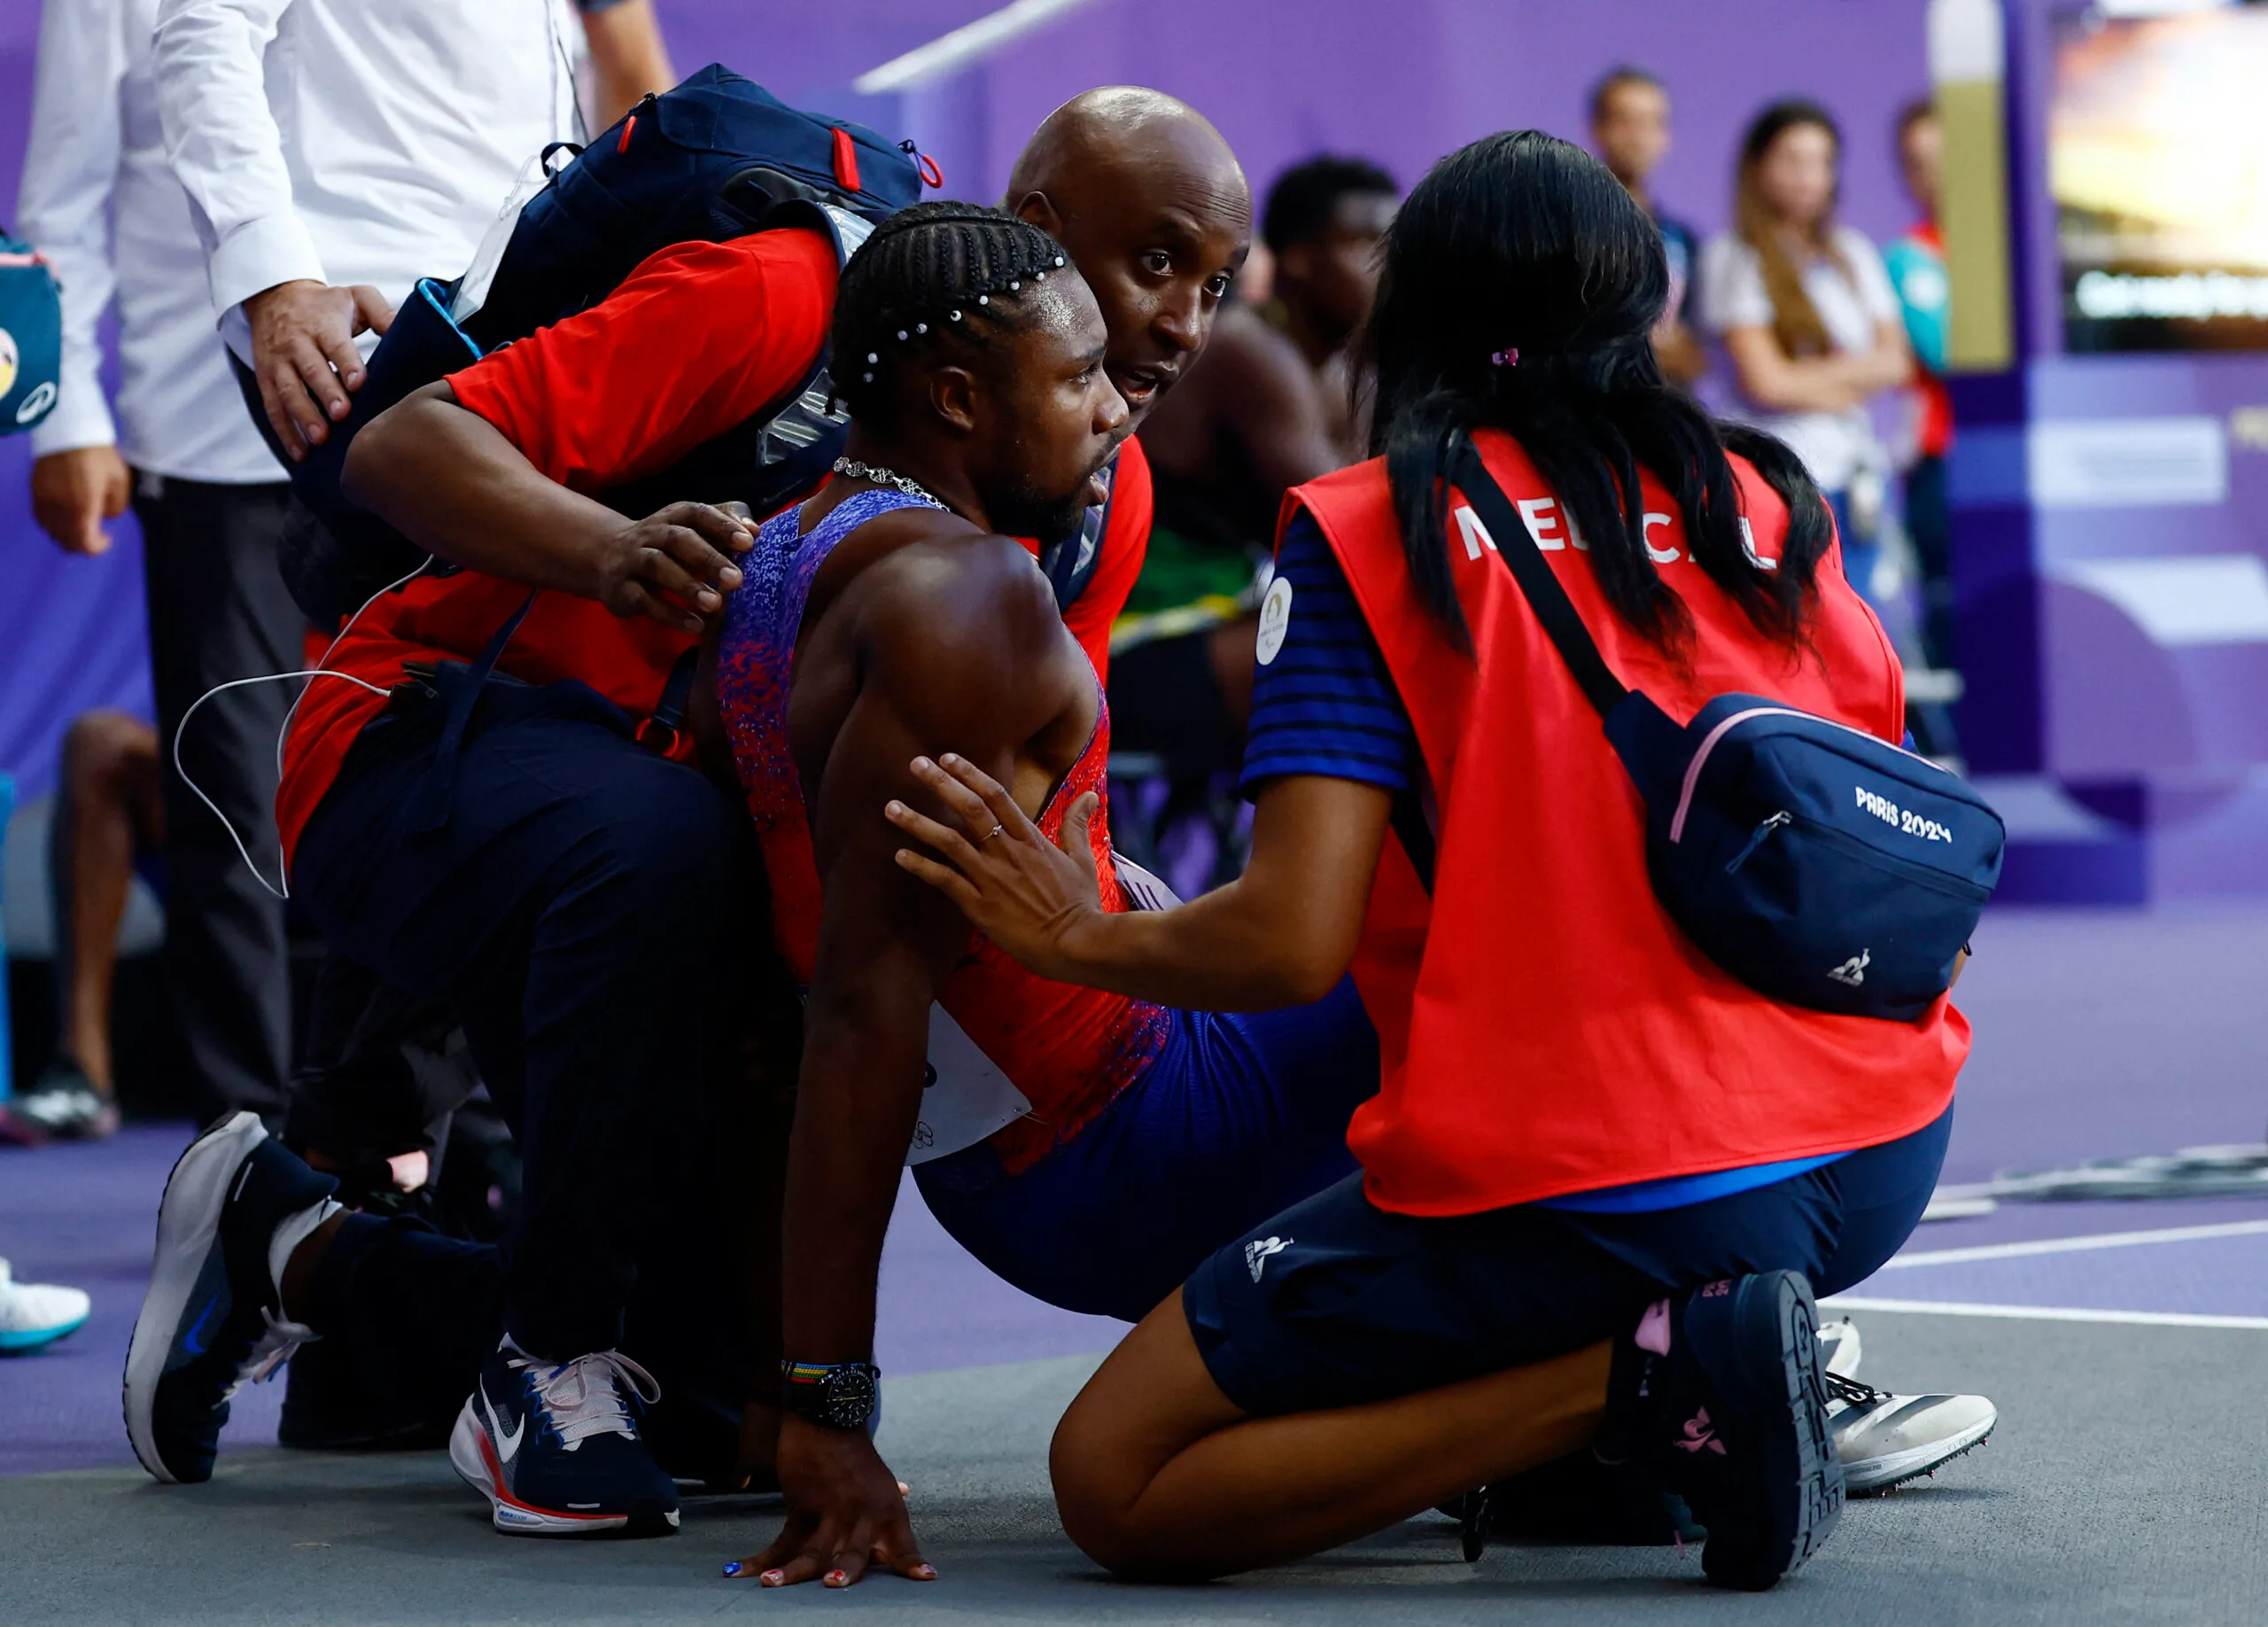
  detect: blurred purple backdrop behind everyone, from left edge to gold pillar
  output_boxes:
[0,0,1928,792]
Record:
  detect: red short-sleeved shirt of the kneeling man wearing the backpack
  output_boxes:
[276,231,835,858]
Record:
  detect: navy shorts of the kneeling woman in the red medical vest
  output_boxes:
[1182,1108,1953,1413]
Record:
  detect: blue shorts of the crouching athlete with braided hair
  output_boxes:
[914,980,1379,1323]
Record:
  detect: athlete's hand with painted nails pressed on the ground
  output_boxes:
[724,1418,936,1588]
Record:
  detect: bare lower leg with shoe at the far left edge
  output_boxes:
[0,712,166,1146]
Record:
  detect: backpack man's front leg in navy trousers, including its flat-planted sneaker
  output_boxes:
[299,692,760,1530]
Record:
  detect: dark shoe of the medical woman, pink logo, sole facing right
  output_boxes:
[1601,1271,1844,1591]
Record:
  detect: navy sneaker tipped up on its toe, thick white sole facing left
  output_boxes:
[125,1112,338,1484]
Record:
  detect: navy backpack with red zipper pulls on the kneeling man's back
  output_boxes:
[281,64,944,627]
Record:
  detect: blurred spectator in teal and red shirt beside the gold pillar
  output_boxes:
[1883,100,1955,667]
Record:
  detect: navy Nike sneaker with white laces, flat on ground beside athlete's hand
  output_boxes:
[449,1339,678,1537]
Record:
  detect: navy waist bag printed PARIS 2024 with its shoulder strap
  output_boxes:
[1456,442,2008,1021]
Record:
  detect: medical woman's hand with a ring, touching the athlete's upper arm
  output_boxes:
[884,756,1102,980]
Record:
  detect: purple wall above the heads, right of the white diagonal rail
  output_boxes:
[884,0,1928,247]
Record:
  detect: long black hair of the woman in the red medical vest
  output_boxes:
[1363,129,1832,653]
